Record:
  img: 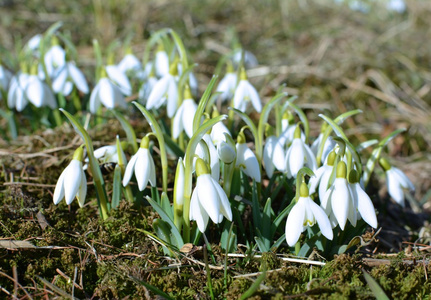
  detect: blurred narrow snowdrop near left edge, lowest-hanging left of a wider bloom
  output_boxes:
[7,70,30,112]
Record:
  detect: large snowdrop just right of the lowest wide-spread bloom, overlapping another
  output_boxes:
[320,161,358,230]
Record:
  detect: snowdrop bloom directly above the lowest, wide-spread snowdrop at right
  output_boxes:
[284,125,317,178]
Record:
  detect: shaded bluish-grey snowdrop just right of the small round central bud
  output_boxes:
[235,131,261,182]
